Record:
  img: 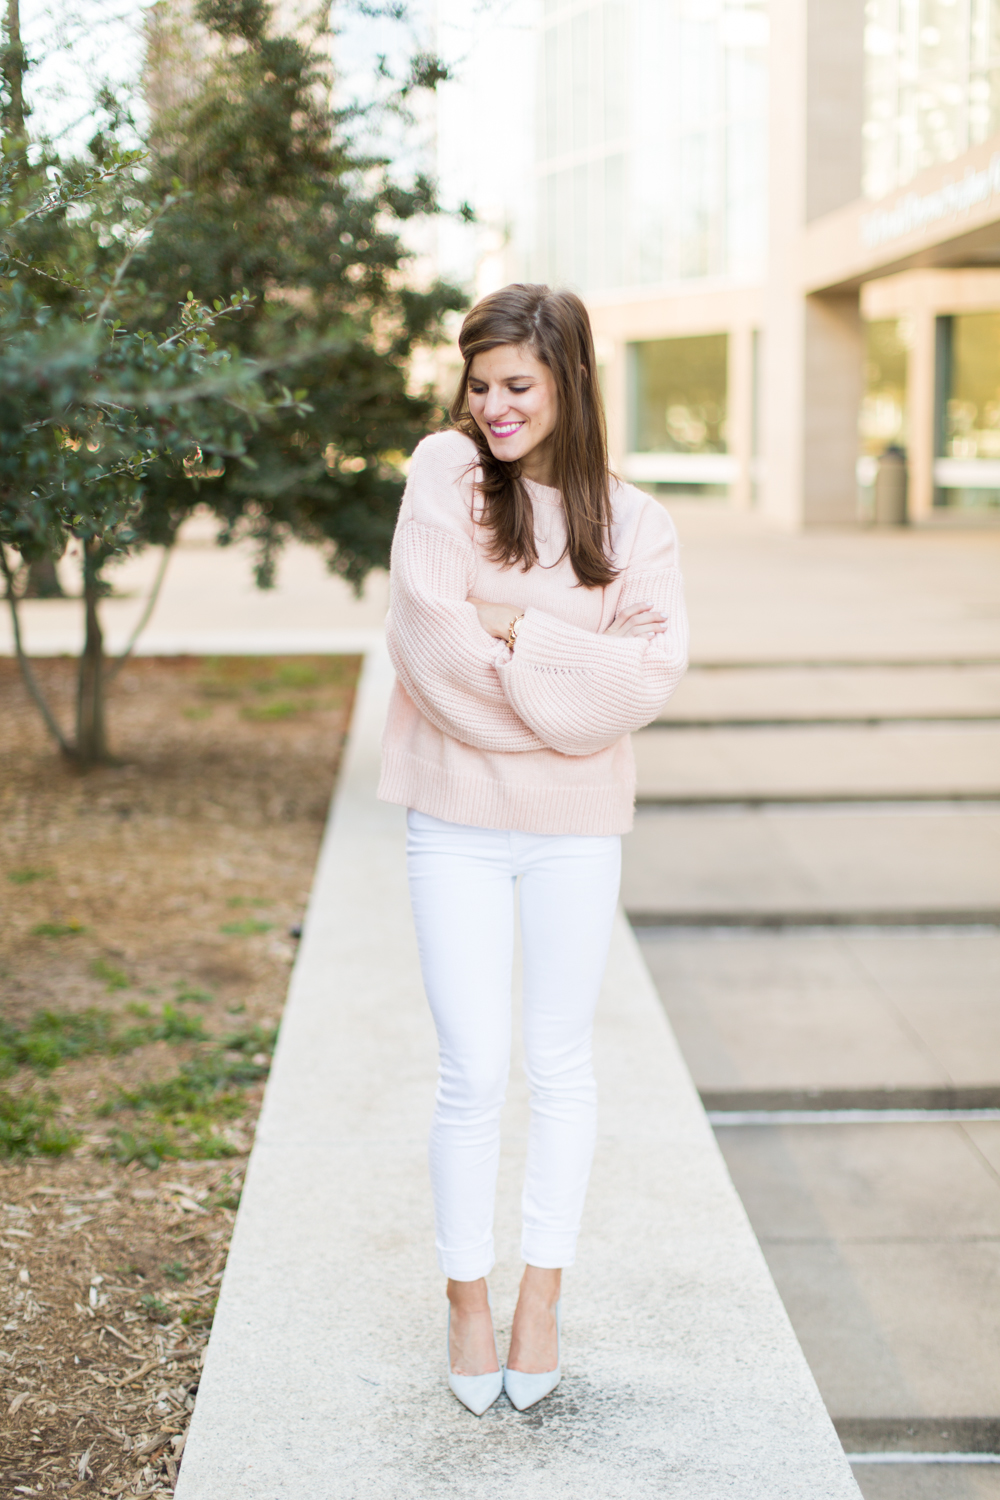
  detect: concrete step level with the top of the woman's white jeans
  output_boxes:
[622,806,1000,923]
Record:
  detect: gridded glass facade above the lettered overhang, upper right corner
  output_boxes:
[864,0,1000,198]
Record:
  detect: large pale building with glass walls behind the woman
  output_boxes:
[500,0,1000,525]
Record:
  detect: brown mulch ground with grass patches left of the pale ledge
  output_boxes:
[0,657,358,1496]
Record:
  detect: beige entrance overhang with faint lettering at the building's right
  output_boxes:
[799,135,1000,293]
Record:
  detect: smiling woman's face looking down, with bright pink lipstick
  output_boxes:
[468,344,558,485]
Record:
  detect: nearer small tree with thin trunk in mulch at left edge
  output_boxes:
[0,158,301,765]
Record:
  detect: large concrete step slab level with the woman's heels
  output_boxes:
[718,1124,1000,1421]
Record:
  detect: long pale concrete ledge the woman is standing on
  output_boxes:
[177,650,859,1500]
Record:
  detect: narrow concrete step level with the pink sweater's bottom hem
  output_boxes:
[633,723,1000,803]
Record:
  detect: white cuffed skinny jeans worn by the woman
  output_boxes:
[406,810,621,1281]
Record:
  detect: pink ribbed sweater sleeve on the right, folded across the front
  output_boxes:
[499,507,688,756]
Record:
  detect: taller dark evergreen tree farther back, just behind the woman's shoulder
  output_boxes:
[133,0,463,585]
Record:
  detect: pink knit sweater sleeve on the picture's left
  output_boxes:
[387,434,543,752]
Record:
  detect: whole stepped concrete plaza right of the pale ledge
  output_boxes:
[624,513,1000,1500]
